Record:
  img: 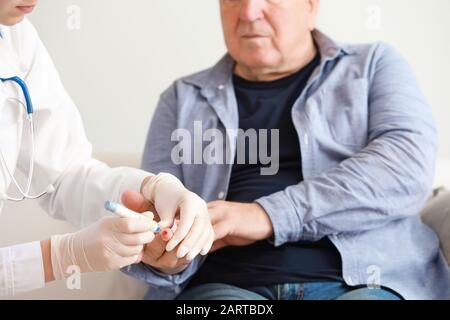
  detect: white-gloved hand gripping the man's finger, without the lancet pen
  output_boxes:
[142,173,214,260]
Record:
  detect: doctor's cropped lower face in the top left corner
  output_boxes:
[0,0,38,26]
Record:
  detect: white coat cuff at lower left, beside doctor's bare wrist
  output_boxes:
[0,241,45,297]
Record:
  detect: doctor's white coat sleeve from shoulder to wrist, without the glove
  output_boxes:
[12,20,150,227]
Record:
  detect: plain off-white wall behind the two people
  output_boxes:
[27,0,450,158]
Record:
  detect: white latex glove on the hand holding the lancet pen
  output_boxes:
[51,216,154,280]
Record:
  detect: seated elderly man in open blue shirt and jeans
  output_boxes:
[123,0,450,299]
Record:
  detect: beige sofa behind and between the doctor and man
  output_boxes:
[0,154,450,299]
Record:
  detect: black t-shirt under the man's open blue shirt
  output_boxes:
[189,55,342,288]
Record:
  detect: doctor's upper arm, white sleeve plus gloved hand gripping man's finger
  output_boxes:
[19,20,212,255]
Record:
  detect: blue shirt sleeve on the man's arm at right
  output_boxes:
[257,44,438,246]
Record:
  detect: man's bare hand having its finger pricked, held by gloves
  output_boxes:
[122,191,206,274]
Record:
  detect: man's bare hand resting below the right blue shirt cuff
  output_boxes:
[208,201,273,252]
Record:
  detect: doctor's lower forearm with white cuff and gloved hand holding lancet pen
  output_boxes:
[0,216,154,297]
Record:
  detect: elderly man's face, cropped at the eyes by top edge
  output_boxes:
[220,0,319,74]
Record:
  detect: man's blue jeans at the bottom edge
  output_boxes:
[177,282,402,300]
